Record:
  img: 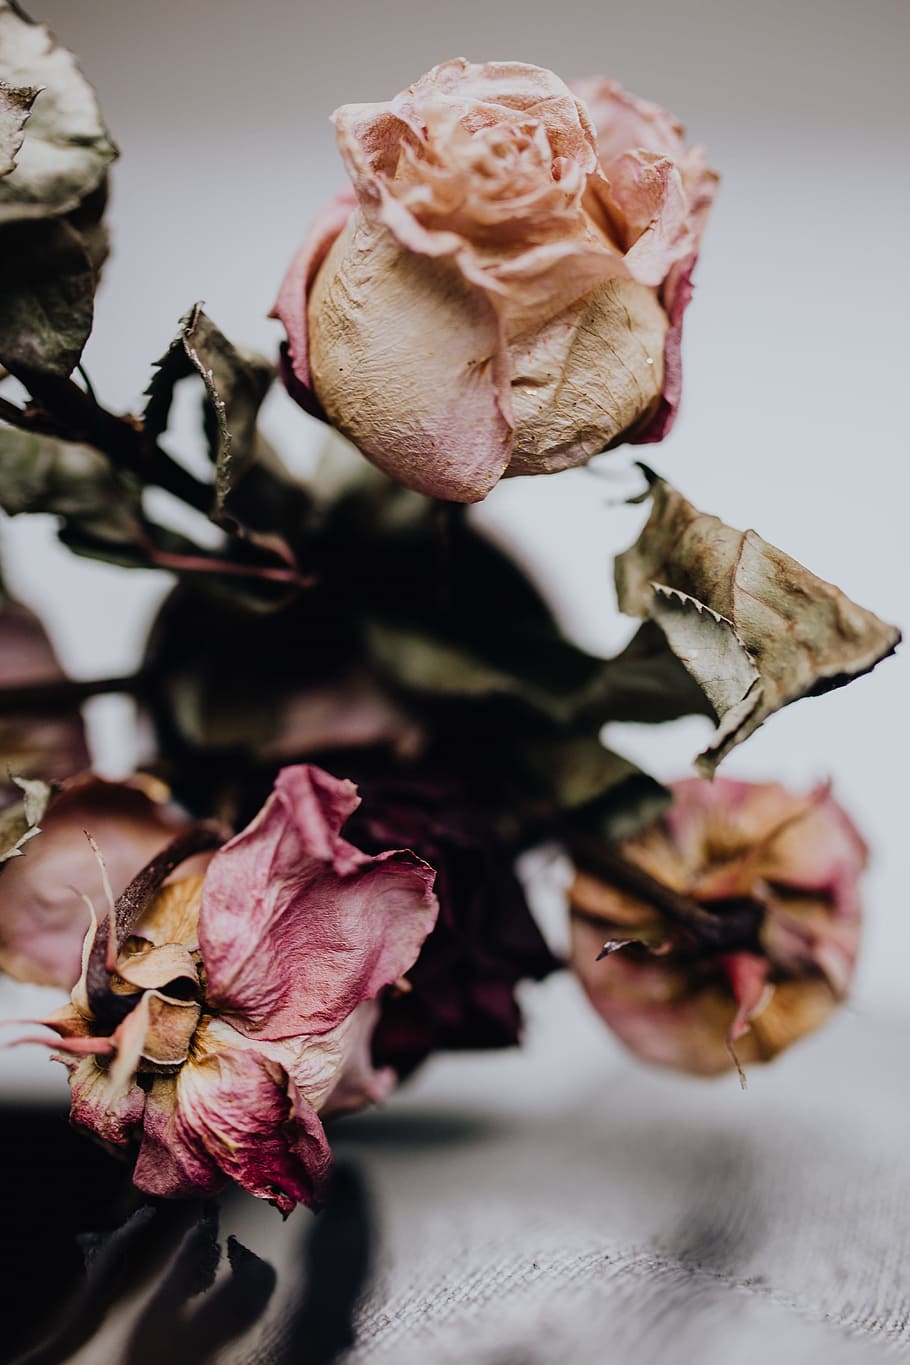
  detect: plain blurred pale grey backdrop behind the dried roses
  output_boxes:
[3,0,910,1080]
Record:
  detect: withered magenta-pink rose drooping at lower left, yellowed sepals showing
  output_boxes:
[29,766,437,1212]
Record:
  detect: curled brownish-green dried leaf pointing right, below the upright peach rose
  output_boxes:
[615,467,900,775]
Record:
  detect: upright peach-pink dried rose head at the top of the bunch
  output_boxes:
[274,59,716,502]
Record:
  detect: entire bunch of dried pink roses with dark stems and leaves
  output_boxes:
[0,0,899,1212]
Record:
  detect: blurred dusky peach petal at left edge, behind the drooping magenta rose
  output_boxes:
[0,777,189,991]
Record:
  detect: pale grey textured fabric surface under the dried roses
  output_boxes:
[206,979,910,1365]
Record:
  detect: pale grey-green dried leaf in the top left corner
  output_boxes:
[0,0,117,224]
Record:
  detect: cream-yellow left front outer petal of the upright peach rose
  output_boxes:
[310,204,512,502]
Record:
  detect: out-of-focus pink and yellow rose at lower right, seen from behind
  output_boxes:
[570,779,866,1078]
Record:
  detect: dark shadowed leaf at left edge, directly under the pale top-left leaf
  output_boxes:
[0,219,97,378]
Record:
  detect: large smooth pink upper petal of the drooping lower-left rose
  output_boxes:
[199,764,437,1039]
